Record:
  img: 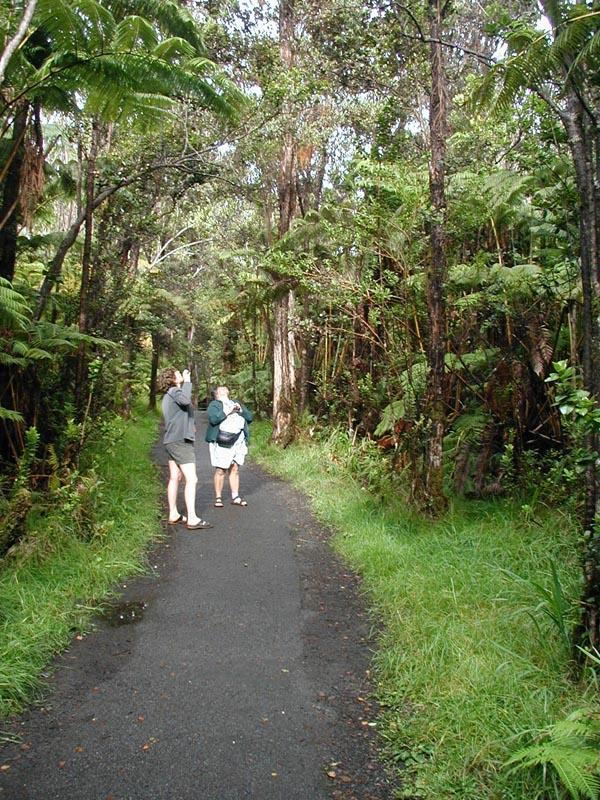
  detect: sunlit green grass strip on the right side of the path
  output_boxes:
[252,423,595,800]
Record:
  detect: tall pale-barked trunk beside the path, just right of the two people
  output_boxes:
[272,0,297,444]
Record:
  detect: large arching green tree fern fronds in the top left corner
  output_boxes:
[6,0,244,120]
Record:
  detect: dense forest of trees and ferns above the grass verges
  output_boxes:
[0,0,600,792]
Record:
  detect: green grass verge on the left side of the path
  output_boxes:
[0,411,162,718]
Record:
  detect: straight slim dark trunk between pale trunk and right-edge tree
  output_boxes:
[425,0,447,514]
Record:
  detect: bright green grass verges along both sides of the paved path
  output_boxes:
[0,407,600,800]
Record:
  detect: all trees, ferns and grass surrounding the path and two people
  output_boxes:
[0,0,600,800]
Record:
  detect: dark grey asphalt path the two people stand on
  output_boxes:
[0,412,393,800]
